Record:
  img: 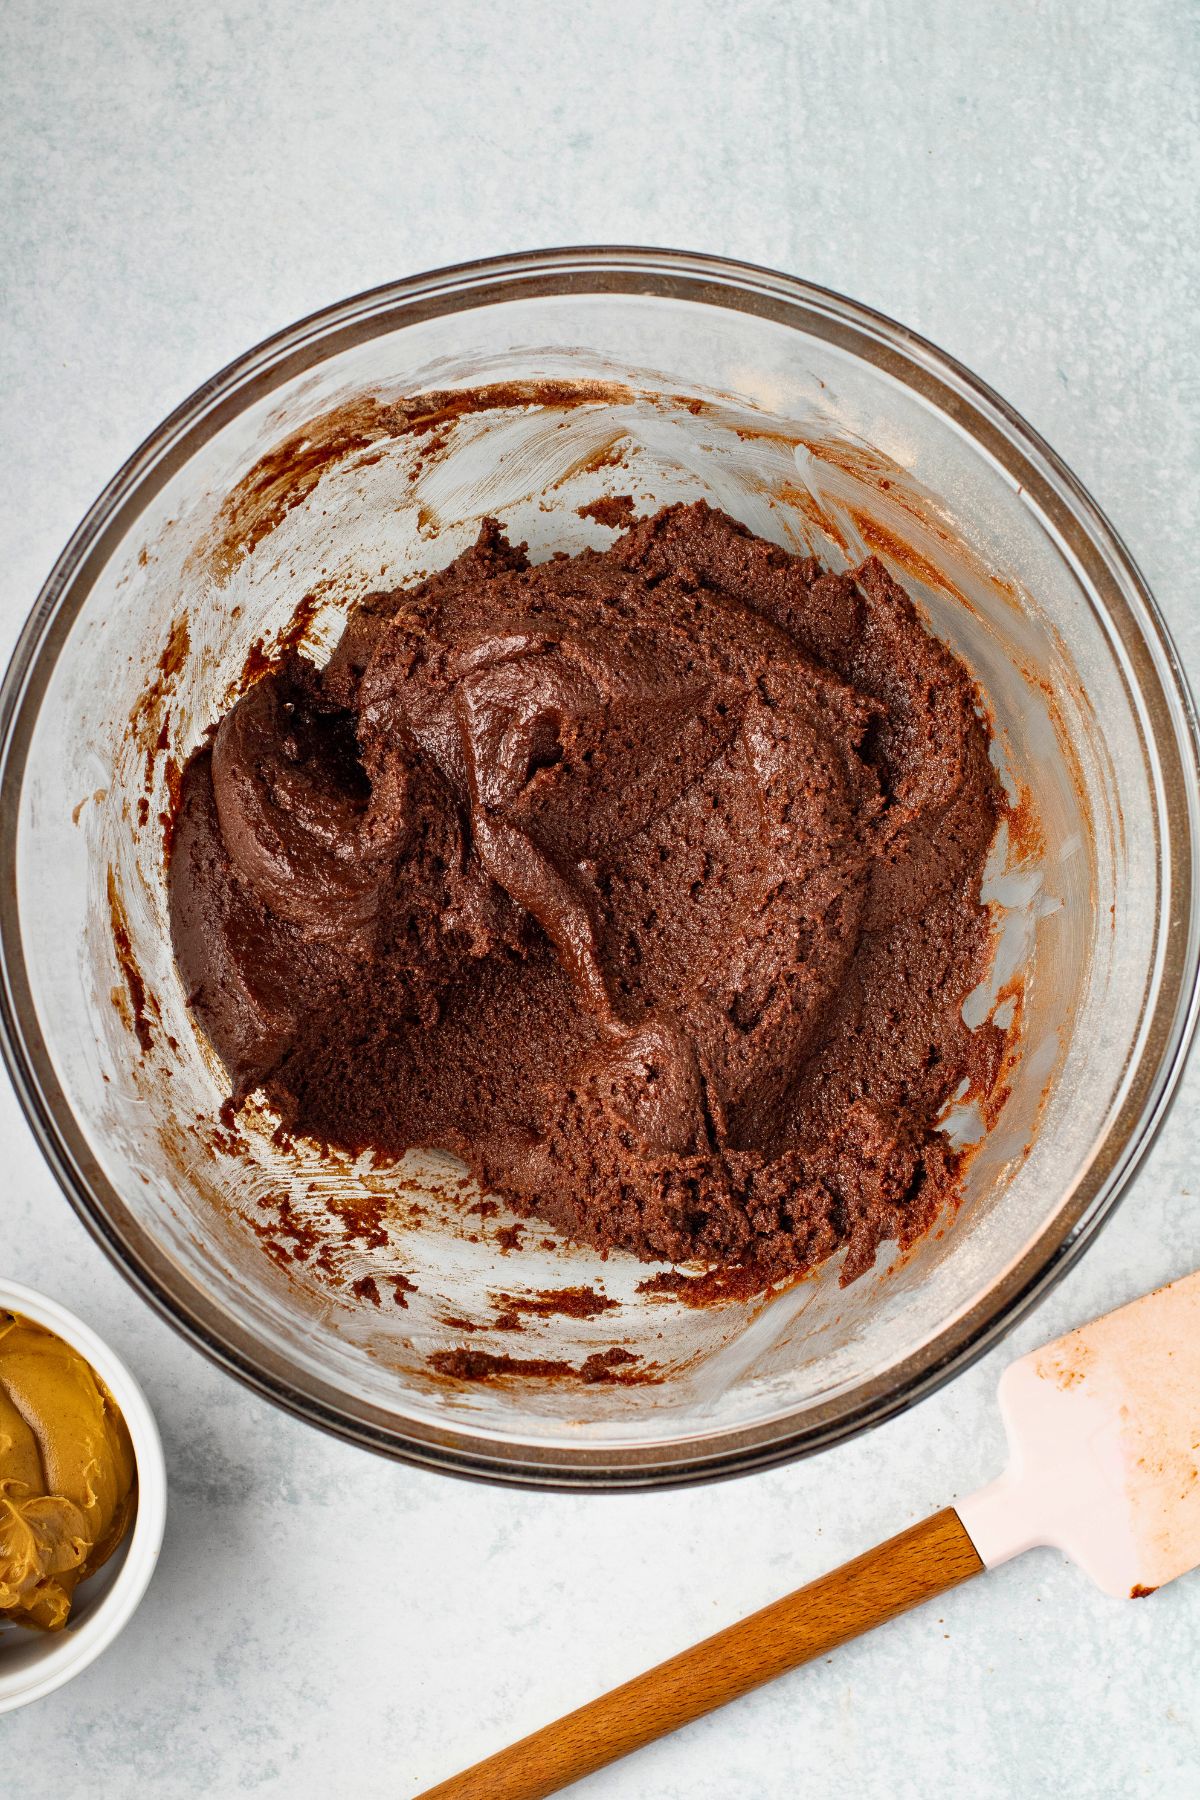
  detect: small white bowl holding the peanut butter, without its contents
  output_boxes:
[0,1282,167,1712]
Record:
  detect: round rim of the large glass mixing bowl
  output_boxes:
[0,245,1200,1490]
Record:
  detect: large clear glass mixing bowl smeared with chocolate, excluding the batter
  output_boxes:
[0,248,1200,1487]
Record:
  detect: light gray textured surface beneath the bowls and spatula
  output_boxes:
[0,0,1200,1800]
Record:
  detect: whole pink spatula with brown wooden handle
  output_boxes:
[419,1273,1200,1800]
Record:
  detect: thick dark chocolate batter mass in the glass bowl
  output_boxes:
[169,504,1002,1280]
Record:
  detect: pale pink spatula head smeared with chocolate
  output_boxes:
[966,1273,1200,1597]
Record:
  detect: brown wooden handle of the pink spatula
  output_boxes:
[417,1507,984,1800]
